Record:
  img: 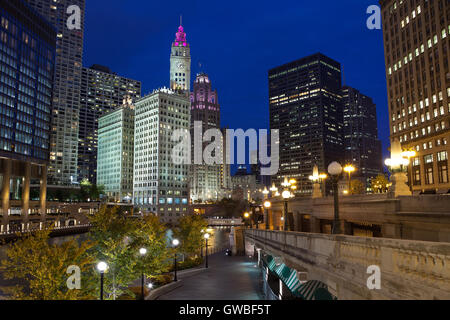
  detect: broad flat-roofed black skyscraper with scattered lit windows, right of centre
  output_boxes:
[269,53,344,194]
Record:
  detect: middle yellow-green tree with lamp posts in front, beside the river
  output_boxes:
[90,206,169,299]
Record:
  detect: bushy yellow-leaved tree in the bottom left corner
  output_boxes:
[1,229,97,300]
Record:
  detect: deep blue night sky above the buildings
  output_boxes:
[84,0,389,166]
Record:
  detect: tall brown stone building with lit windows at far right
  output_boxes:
[380,0,450,192]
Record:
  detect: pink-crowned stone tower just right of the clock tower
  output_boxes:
[189,73,222,201]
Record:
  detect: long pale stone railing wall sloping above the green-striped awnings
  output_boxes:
[245,230,450,299]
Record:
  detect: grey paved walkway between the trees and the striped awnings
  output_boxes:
[158,253,262,300]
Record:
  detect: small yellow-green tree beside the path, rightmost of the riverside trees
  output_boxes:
[175,215,208,255]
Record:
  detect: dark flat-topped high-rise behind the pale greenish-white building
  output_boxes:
[78,65,141,183]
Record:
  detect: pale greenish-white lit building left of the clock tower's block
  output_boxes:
[96,96,135,202]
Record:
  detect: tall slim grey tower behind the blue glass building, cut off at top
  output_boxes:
[27,0,85,185]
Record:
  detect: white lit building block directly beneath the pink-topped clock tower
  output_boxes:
[133,88,190,222]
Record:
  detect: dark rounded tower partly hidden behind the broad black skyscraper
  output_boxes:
[342,86,382,183]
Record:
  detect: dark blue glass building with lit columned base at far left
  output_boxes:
[0,0,56,233]
